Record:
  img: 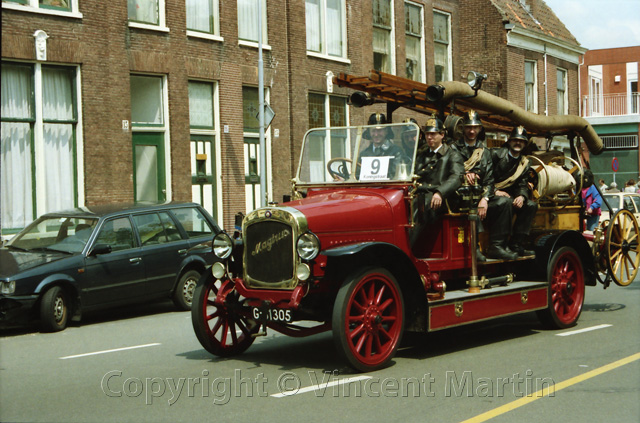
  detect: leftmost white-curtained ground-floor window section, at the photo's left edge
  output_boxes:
[0,64,33,228]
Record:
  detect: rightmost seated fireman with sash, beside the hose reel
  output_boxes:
[492,126,538,256]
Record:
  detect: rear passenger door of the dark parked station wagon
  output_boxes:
[133,211,189,296]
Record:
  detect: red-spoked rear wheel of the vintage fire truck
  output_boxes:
[538,247,585,329]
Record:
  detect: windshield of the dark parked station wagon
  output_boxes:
[7,216,98,253]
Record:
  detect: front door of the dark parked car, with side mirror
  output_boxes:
[82,216,145,307]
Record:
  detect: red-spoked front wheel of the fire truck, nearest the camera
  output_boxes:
[332,268,404,372]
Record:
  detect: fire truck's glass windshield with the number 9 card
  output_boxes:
[297,123,420,184]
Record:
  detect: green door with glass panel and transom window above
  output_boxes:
[131,75,167,202]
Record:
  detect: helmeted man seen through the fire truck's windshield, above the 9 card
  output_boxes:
[358,113,410,179]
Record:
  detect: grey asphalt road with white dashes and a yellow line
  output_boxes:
[0,278,640,423]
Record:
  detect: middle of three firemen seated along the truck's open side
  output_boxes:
[452,110,518,261]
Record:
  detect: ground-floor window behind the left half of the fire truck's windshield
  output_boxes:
[309,93,351,181]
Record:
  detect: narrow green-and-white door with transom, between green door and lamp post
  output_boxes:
[189,81,218,220]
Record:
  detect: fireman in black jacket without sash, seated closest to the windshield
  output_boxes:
[410,116,464,256]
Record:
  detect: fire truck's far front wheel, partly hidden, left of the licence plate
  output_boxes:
[191,272,259,357]
